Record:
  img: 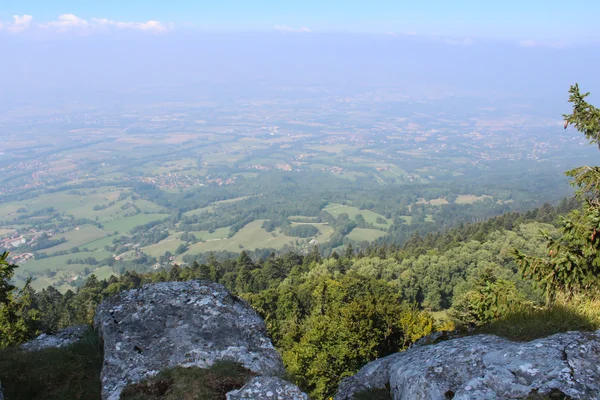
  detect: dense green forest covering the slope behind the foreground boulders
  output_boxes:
[3,194,592,398]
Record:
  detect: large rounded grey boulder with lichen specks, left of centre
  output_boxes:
[94,281,283,400]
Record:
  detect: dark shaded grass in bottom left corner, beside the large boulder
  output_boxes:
[0,330,103,400]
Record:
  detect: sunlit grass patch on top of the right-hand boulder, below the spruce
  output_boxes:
[476,296,600,341]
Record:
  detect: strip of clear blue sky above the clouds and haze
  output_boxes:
[0,0,600,42]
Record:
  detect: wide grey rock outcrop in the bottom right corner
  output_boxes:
[335,331,600,400]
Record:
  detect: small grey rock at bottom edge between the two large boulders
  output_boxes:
[227,376,308,400]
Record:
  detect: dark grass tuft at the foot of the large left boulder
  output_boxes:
[121,361,254,400]
